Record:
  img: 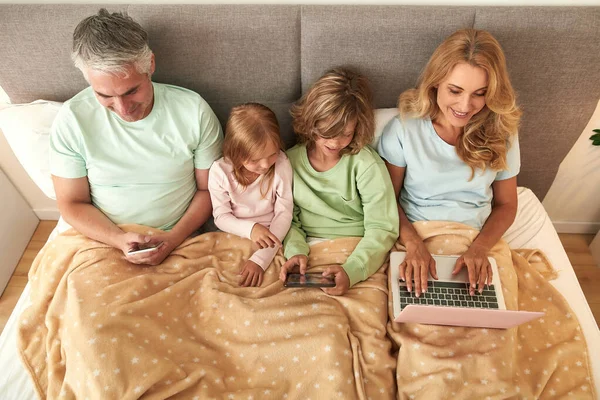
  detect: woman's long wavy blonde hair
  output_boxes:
[398,29,521,179]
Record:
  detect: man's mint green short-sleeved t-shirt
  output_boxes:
[50,83,223,230]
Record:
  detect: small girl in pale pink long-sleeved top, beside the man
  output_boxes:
[208,103,294,286]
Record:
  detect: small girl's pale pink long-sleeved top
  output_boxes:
[208,151,294,270]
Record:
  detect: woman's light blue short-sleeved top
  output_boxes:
[377,116,521,229]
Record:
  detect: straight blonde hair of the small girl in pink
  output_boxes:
[223,103,283,198]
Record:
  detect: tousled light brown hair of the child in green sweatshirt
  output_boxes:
[291,68,375,155]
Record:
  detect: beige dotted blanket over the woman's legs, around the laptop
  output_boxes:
[388,222,597,399]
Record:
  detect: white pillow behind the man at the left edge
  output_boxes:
[0,100,62,199]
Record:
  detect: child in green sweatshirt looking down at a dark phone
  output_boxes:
[280,68,398,295]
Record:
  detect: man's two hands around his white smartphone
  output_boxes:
[121,232,183,265]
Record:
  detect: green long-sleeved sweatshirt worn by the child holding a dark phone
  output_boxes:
[284,145,399,286]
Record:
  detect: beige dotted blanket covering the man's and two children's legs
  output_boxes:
[18,226,396,400]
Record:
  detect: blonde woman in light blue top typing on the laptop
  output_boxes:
[378,29,521,296]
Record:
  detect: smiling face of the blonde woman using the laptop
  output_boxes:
[437,63,488,128]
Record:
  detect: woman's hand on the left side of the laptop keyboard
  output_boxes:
[400,241,437,297]
